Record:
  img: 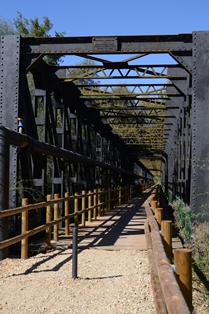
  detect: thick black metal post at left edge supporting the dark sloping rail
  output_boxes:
[0,126,9,260]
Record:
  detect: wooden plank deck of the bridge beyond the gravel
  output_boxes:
[52,192,181,250]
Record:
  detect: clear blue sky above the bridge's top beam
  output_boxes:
[0,0,209,36]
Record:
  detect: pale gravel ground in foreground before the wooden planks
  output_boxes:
[0,247,155,314]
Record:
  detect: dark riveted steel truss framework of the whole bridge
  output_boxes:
[0,32,209,221]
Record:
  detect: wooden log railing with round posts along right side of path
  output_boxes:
[145,186,192,314]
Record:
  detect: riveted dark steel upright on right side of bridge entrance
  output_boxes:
[191,32,209,221]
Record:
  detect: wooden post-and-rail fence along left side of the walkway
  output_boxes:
[0,184,151,259]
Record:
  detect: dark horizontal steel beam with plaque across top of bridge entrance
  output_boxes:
[21,34,192,55]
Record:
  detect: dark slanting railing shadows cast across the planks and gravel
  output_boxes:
[13,192,150,276]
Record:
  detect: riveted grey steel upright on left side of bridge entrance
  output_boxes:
[0,35,20,207]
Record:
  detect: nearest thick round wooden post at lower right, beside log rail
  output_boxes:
[174,249,192,312]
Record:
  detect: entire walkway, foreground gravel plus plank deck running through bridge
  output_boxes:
[0,193,183,314]
